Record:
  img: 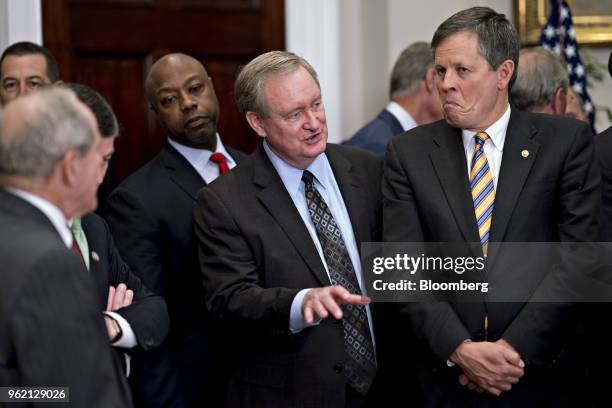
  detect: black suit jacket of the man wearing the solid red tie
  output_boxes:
[107,144,243,407]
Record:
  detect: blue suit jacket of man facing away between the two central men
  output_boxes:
[344,109,404,156]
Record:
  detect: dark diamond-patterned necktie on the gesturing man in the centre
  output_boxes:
[302,171,376,395]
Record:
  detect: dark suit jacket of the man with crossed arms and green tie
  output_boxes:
[81,213,170,350]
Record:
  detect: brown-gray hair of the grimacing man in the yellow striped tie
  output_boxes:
[431,7,520,89]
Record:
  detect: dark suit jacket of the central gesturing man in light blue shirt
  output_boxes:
[195,144,382,407]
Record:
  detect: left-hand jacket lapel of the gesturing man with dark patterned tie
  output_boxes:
[252,144,330,286]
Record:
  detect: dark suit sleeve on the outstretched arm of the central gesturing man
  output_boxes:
[194,187,299,334]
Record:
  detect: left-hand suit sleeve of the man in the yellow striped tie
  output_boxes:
[382,139,471,362]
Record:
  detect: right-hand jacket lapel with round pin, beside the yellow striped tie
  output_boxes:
[490,109,540,242]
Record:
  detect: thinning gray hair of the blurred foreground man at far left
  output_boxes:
[0,87,95,180]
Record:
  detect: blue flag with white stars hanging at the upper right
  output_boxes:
[540,0,596,134]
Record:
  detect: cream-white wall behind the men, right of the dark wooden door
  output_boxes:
[286,0,612,141]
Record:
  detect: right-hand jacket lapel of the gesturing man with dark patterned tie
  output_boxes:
[326,145,370,252]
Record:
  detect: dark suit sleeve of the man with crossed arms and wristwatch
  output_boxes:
[100,220,170,350]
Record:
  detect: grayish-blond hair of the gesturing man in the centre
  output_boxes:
[234,51,321,118]
